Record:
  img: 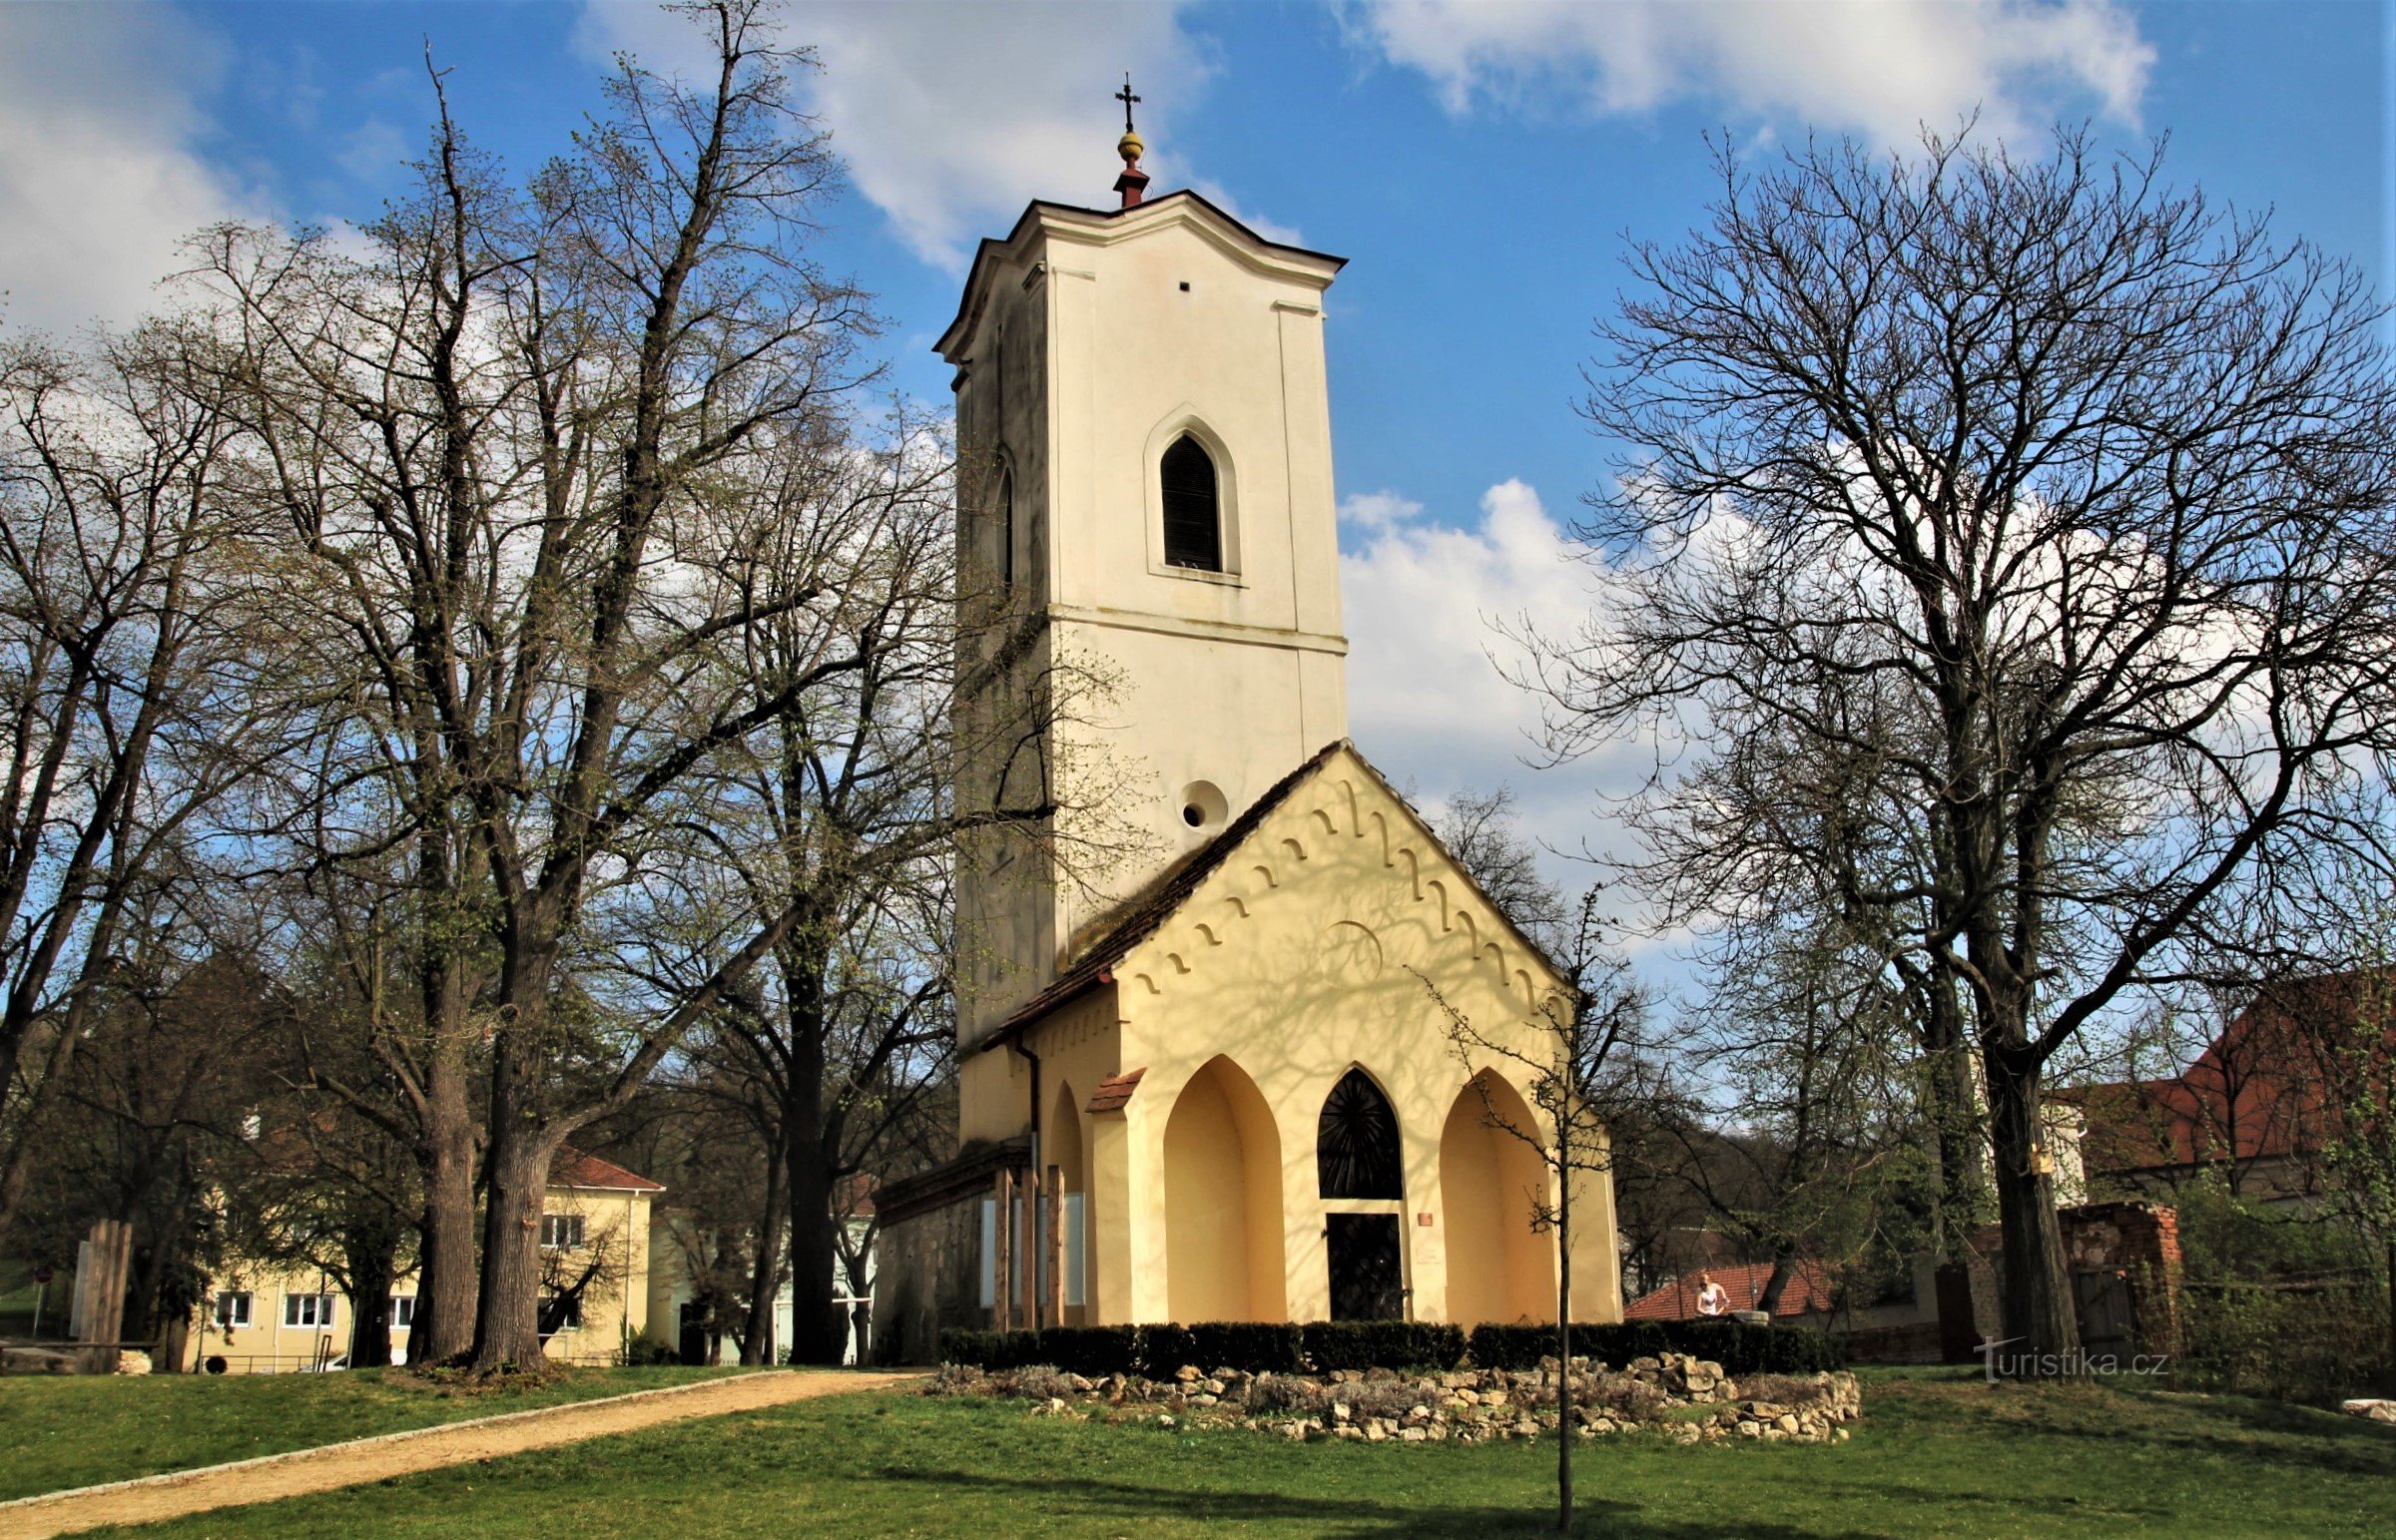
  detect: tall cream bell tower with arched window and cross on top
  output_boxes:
[936,114,1347,1044]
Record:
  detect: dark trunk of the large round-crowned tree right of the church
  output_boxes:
[1984,1044,2080,1379]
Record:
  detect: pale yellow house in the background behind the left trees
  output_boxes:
[180,1150,666,1374]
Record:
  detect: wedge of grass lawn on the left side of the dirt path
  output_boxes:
[0,1367,743,1499]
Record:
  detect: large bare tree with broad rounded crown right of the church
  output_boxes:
[1540,134,2396,1365]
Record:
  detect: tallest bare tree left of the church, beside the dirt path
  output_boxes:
[196,0,900,1370]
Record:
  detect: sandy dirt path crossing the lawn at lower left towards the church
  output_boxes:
[0,1370,912,1540]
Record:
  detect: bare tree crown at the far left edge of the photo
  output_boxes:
[0,323,281,1234]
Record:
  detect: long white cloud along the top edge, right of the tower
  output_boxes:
[1344,0,2154,144]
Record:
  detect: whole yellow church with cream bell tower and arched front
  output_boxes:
[875,134,1619,1360]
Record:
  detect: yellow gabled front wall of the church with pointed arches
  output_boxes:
[963,750,1619,1324]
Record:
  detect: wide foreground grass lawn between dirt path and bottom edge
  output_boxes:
[51,1370,2396,1540]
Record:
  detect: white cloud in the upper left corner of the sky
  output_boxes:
[0,5,264,333]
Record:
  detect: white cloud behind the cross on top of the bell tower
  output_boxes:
[582,0,1265,268]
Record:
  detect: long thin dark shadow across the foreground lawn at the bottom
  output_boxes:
[880,1466,1859,1540]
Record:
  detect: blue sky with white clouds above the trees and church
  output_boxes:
[0,0,2396,986]
